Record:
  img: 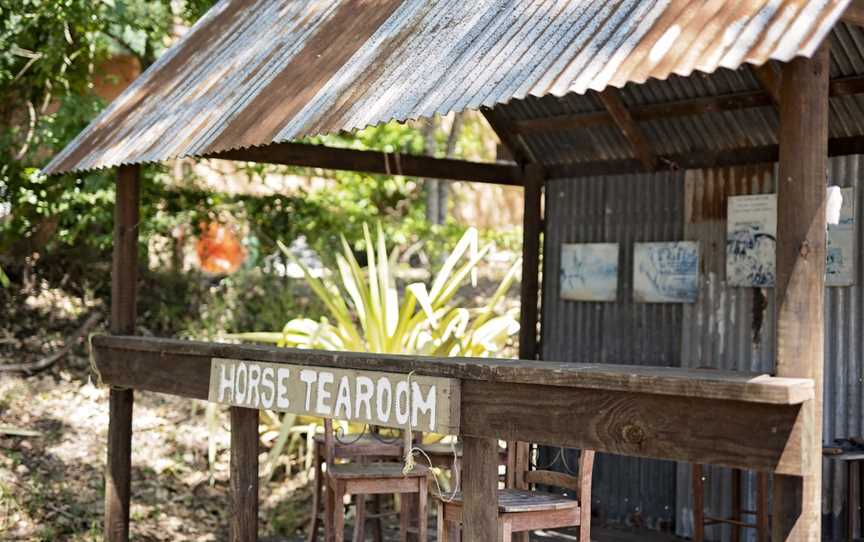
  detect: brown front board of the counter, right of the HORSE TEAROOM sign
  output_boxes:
[462,380,802,474]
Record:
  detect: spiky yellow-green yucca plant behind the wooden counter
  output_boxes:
[224,224,521,479]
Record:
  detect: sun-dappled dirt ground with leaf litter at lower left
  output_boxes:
[0,371,310,541]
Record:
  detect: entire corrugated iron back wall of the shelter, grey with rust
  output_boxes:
[541,156,864,540]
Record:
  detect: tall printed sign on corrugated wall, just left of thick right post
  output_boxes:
[726,194,777,288]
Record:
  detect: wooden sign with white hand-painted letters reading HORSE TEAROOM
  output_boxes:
[209,358,460,434]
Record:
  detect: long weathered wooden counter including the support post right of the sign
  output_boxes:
[92,336,814,540]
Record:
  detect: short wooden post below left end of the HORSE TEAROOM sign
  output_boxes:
[229,407,258,542]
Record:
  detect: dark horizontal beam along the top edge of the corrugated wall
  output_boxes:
[546,136,864,181]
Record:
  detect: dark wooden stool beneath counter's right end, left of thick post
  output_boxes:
[692,464,771,542]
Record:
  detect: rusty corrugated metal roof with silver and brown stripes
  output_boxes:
[46,0,849,173]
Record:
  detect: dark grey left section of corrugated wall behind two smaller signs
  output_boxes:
[540,173,684,529]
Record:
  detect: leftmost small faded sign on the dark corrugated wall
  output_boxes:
[561,243,618,301]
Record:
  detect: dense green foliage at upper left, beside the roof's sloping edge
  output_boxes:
[0,0,214,262]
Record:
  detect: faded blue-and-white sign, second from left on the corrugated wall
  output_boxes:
[633,241,699,303]
